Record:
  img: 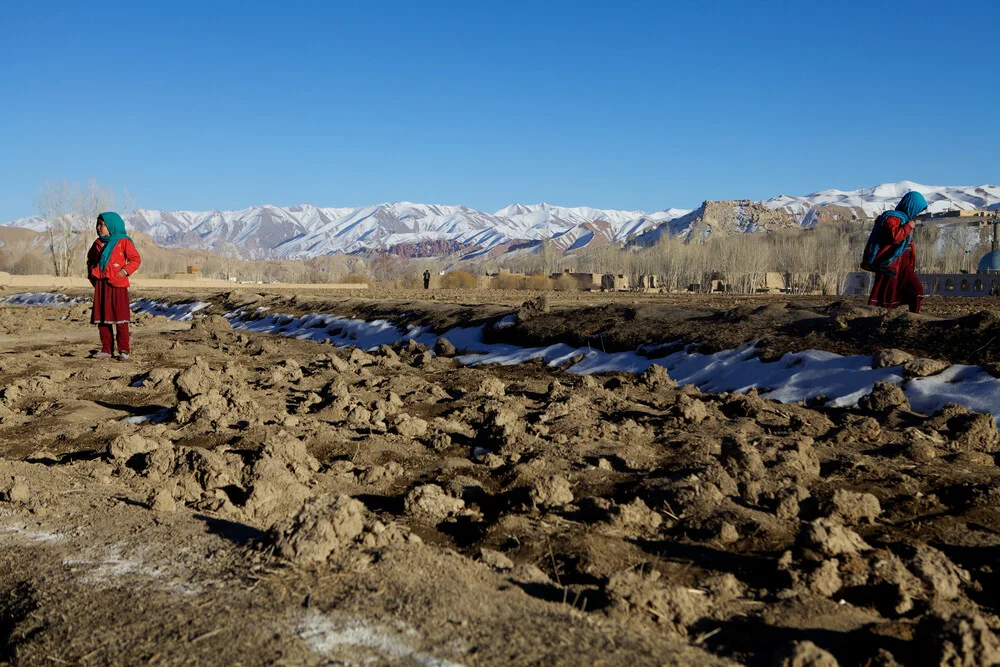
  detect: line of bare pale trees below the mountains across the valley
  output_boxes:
[11,221,990,293]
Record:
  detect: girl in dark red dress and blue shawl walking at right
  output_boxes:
[868,191,927,313]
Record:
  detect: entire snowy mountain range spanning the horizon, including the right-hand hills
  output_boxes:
[2,181,1000,259]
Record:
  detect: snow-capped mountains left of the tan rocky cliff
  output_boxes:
[0,202,687,259]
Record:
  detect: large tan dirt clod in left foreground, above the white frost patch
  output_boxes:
[271,495,365,565]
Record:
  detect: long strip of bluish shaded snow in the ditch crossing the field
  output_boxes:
[226,311,1000,428]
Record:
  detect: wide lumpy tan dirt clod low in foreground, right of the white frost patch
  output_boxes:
[604,570,711,636]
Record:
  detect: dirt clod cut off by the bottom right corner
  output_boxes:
[917,611,1000,667]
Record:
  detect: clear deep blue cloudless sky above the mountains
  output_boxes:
[0,0,1000,220]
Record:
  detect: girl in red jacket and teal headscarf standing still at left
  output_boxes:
[87,211,142,361]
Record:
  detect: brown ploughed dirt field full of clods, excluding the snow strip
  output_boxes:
[0,289,1000,666]
